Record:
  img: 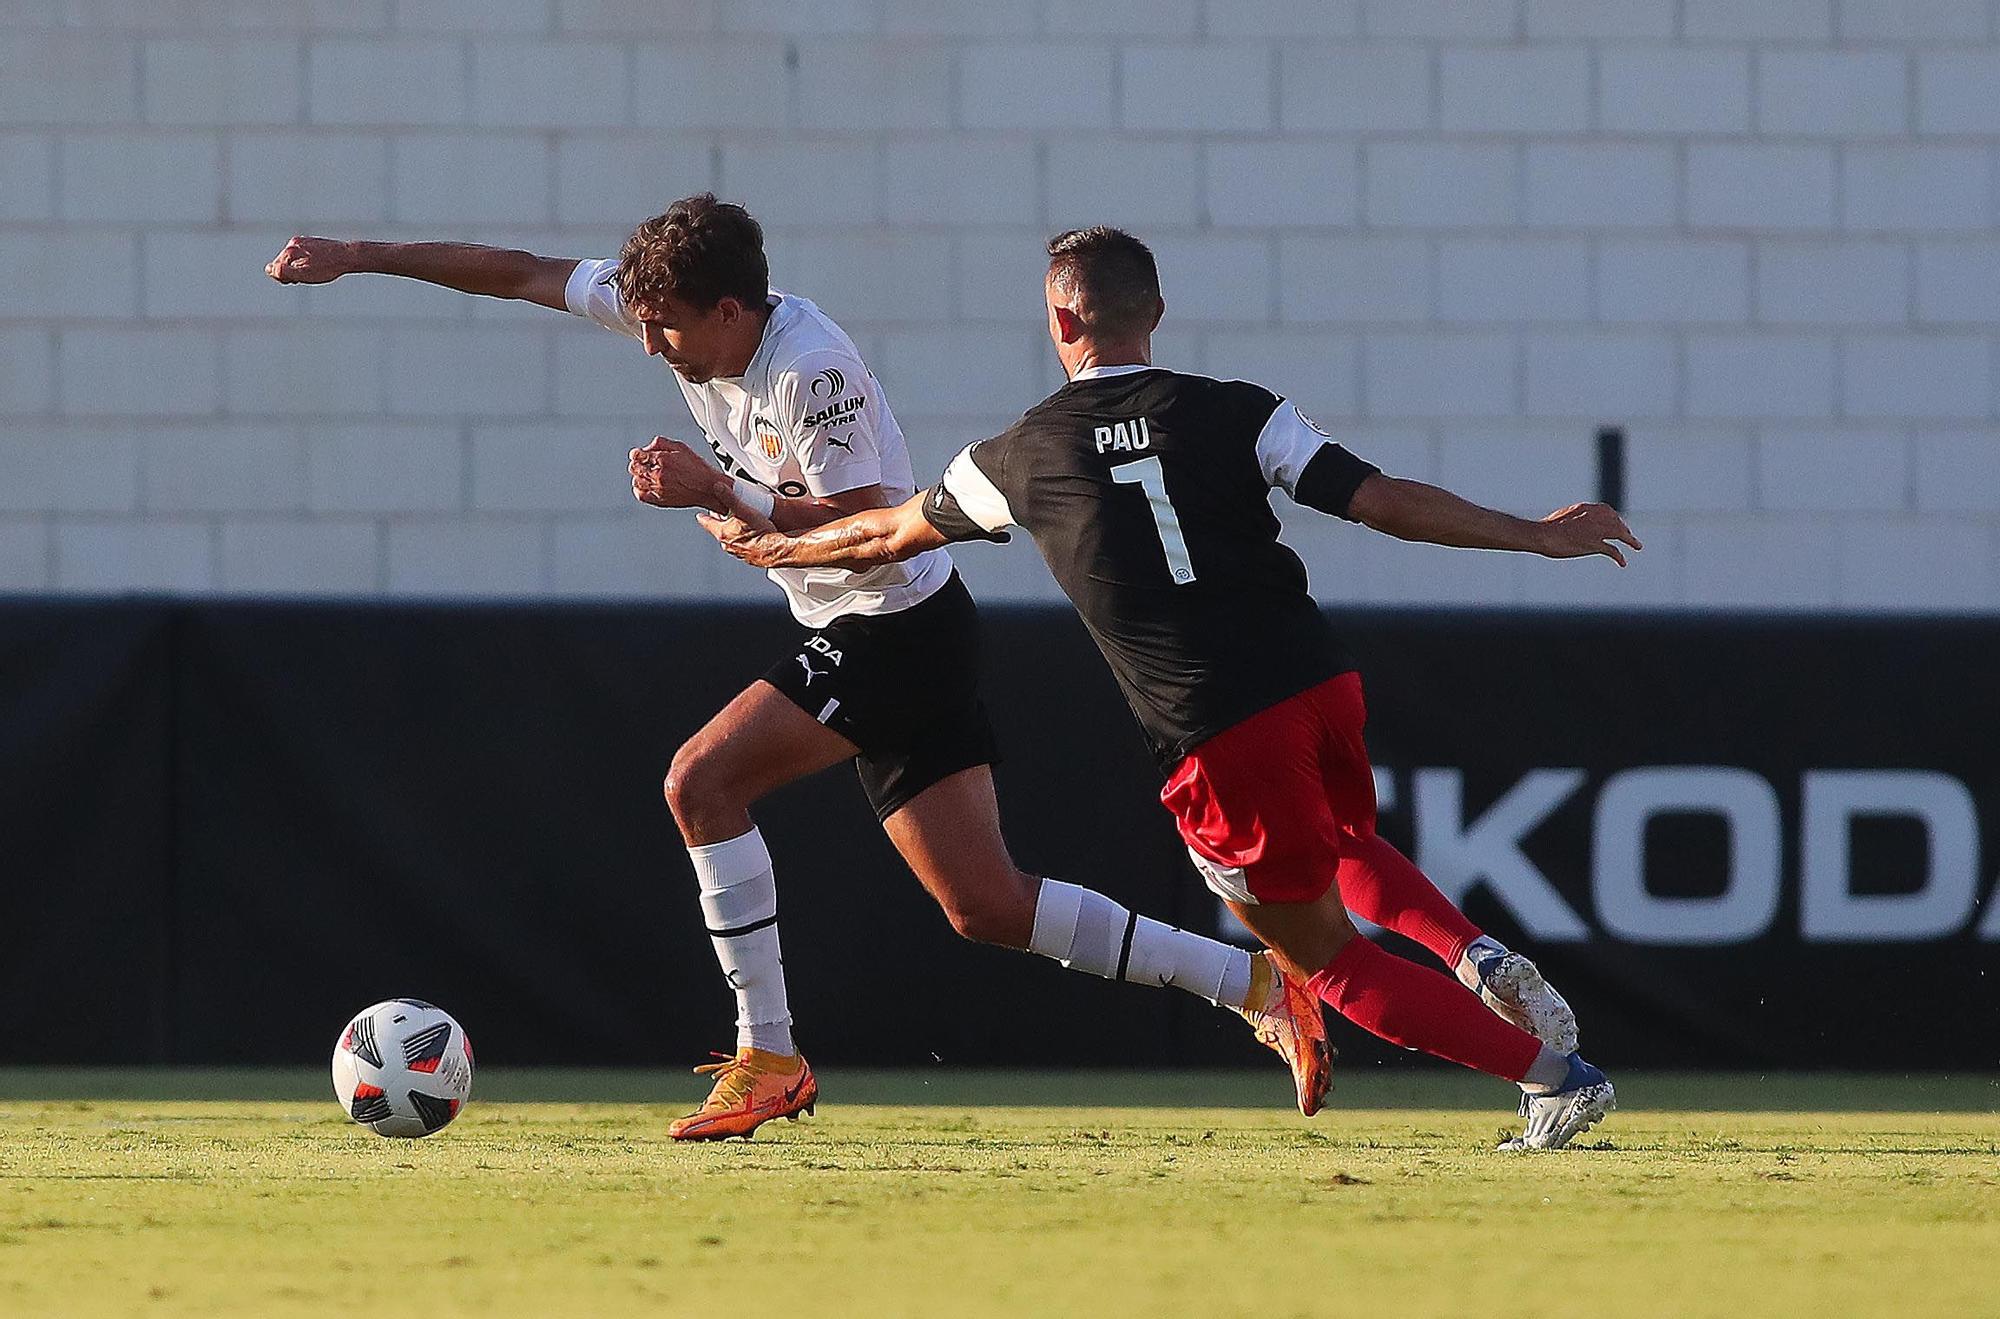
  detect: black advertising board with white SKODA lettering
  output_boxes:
[0,600,2000,1071]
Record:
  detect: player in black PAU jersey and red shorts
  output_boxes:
[704,228,1640,1149]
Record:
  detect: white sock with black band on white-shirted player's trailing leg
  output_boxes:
[1028,879,1262,1007]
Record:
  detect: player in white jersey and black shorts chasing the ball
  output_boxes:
[268,194,1328,1139]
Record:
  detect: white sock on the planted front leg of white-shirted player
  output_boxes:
[688,829,798,1053]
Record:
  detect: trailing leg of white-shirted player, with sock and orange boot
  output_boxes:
[882,765,1332,1117]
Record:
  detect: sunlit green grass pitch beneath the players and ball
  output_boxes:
[0,1069,2000,1319]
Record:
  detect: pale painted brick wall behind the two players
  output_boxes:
[0,0,2000,612]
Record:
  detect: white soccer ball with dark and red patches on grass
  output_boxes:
[334,999,472,1135]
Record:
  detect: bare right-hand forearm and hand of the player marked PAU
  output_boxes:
[1348,474,1640,568]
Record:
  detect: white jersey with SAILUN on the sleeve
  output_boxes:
[564,262,952,628]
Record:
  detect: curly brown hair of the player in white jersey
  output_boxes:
[618,192,770,310]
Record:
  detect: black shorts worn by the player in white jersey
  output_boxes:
[764,572,1000,819]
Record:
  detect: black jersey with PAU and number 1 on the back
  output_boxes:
[924,368,1376,765]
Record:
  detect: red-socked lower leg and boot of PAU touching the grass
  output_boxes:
[1230,889,1616,1149]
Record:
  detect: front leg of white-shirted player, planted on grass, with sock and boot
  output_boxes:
[666,681,856,1139]
